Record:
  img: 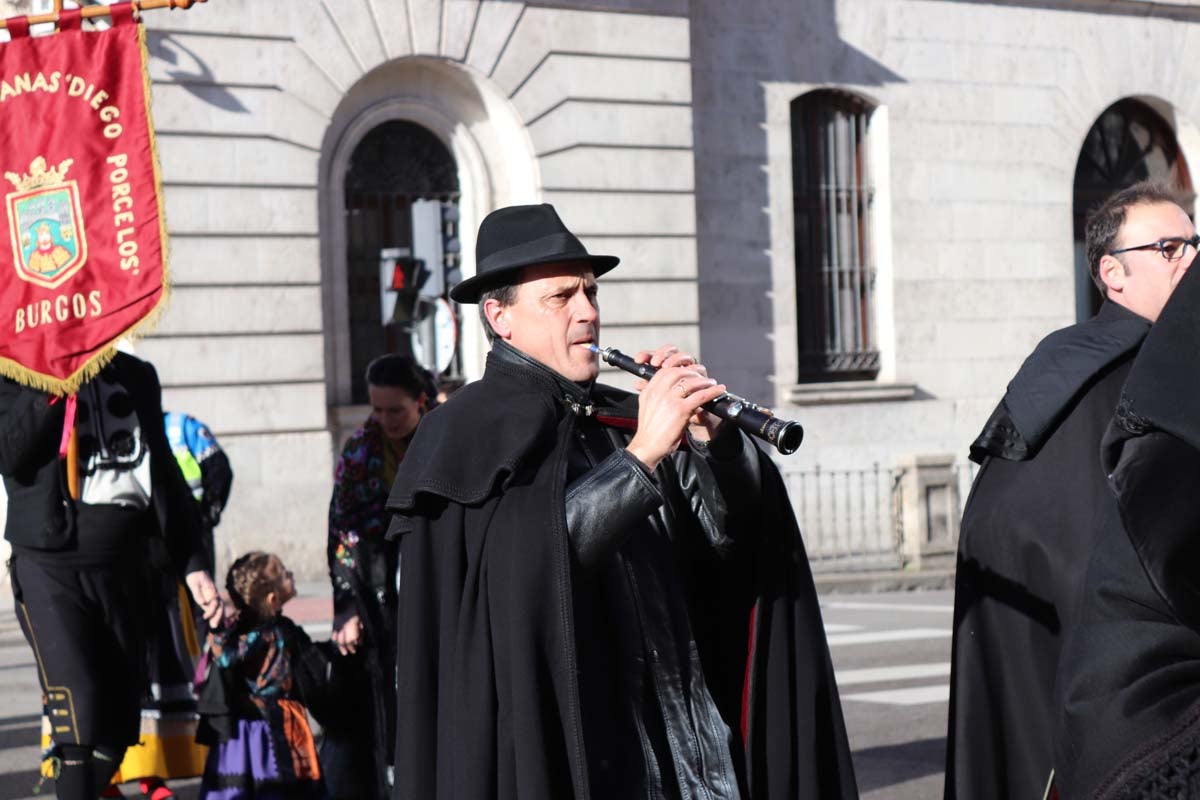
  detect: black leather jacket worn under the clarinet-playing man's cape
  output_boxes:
[493,343,760,800]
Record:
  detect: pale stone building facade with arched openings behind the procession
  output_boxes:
[2,0,1200,575]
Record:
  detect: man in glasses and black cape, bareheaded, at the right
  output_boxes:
[946,182,1200,800]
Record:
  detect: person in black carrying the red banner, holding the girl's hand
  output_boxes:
[0,353,223,800]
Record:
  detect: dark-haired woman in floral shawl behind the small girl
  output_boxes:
[322,355,432,800]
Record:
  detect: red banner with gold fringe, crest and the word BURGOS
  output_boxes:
[0,4,167,395]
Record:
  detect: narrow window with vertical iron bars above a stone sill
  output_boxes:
[791,89,880,383]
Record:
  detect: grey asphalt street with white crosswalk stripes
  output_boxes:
[0,588,953,800]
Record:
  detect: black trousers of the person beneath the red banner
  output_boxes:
[12,553,149,753]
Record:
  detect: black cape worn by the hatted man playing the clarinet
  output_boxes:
[388,357,857,800]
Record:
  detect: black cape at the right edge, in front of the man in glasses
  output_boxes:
[1056,263,1200,800]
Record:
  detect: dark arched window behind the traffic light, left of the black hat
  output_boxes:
[344,120,461,403]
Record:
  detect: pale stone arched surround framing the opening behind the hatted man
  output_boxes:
[318,56,541,422]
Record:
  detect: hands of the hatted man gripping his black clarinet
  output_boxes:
[625,344,725,469]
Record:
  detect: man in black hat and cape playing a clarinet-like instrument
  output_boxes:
[388,205,857,800]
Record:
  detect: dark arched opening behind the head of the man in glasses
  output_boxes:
[1073,98,1193,321]
